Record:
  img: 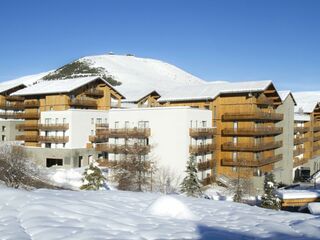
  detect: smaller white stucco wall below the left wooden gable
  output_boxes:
[40,109,109,149]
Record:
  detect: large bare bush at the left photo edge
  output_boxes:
[0,144,37,188]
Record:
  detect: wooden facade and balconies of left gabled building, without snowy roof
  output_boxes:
[14,78,124,147]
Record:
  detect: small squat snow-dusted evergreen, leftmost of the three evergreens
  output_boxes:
[80,162,106,190]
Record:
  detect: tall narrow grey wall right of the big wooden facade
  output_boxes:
[273,95,294,184]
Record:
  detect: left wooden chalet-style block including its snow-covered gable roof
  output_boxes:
[12,77,124,147]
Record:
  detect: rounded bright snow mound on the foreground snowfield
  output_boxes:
[148,196,196,220]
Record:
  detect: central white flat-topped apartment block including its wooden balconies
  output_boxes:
[90,107,215,180]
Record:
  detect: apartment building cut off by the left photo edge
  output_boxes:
[0,83,26,142]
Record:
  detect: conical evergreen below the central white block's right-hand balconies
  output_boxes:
[181,155,202,197]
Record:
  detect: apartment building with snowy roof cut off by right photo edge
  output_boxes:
[293,92,320,178]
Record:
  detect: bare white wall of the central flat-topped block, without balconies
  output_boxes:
[108,107,212,180]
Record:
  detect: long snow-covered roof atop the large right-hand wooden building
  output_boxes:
[159,80,272,102]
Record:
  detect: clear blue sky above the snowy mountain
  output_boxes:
[0,0,320,91]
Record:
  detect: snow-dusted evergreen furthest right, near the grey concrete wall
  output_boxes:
[261,173,281,210]
